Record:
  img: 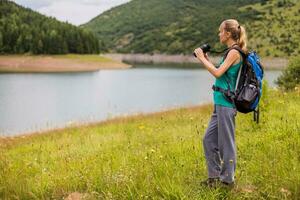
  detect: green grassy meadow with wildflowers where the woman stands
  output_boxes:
[0,86,300,199]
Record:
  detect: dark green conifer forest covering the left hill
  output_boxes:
[0,0,99,54]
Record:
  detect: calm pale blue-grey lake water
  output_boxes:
[0,67,280,136]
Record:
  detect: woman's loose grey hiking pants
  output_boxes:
[203,105,236,183]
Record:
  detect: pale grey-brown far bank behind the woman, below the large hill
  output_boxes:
[102,54,288,70]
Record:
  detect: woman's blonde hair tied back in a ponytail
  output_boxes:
[223,19,248,53]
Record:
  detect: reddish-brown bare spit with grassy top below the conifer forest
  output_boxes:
[0,55,131,72]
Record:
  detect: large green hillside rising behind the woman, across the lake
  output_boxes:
[82,0,300,56]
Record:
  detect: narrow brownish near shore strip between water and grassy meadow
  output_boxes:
[0,103,212,141]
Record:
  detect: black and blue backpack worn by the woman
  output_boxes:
[213,46,264,123]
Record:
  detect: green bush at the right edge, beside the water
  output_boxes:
[277,57,300,90]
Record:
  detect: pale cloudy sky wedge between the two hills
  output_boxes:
[13,0,130,25]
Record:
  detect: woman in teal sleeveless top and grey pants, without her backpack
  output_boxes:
[195,19,247,187]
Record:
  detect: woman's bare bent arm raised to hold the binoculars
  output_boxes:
[195,48,240,78]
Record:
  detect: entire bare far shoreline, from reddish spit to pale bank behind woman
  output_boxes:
[0,54,288,73]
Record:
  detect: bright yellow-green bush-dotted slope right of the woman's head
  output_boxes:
[240,0,300,57]
